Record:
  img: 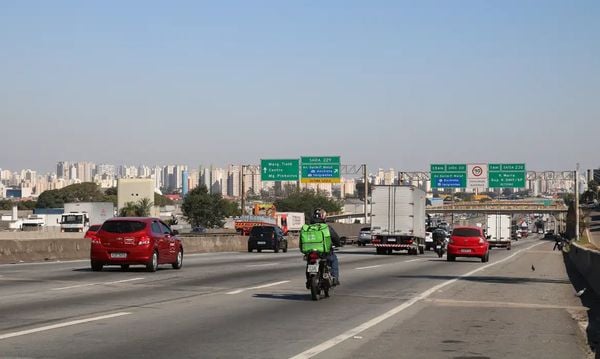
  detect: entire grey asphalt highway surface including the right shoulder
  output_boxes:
[0,235,588,358]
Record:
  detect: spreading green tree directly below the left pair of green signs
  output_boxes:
[275,189,342,219]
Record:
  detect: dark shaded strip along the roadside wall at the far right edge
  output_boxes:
[563,253,600,359]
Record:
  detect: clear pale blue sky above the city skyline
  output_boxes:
[0,0,600,171]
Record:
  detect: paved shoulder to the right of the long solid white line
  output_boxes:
[317,242,588,358]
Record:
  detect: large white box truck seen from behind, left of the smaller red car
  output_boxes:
[371,186,426,255]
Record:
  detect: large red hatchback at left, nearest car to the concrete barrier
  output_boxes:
[90,217,183,272]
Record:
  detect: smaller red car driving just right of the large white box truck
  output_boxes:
[446,227,490,262]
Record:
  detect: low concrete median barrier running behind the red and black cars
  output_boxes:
[0,233,298,264]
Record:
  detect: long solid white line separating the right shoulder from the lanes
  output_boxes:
[290,242,544,359]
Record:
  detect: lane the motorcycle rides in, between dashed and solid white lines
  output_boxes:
[0,240,536,358]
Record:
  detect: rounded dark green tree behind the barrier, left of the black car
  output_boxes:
[181,185,232,228]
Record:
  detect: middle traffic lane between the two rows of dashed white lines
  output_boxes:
[0,250,446,331]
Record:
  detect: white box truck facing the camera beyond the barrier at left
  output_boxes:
[60,202,115,232]
